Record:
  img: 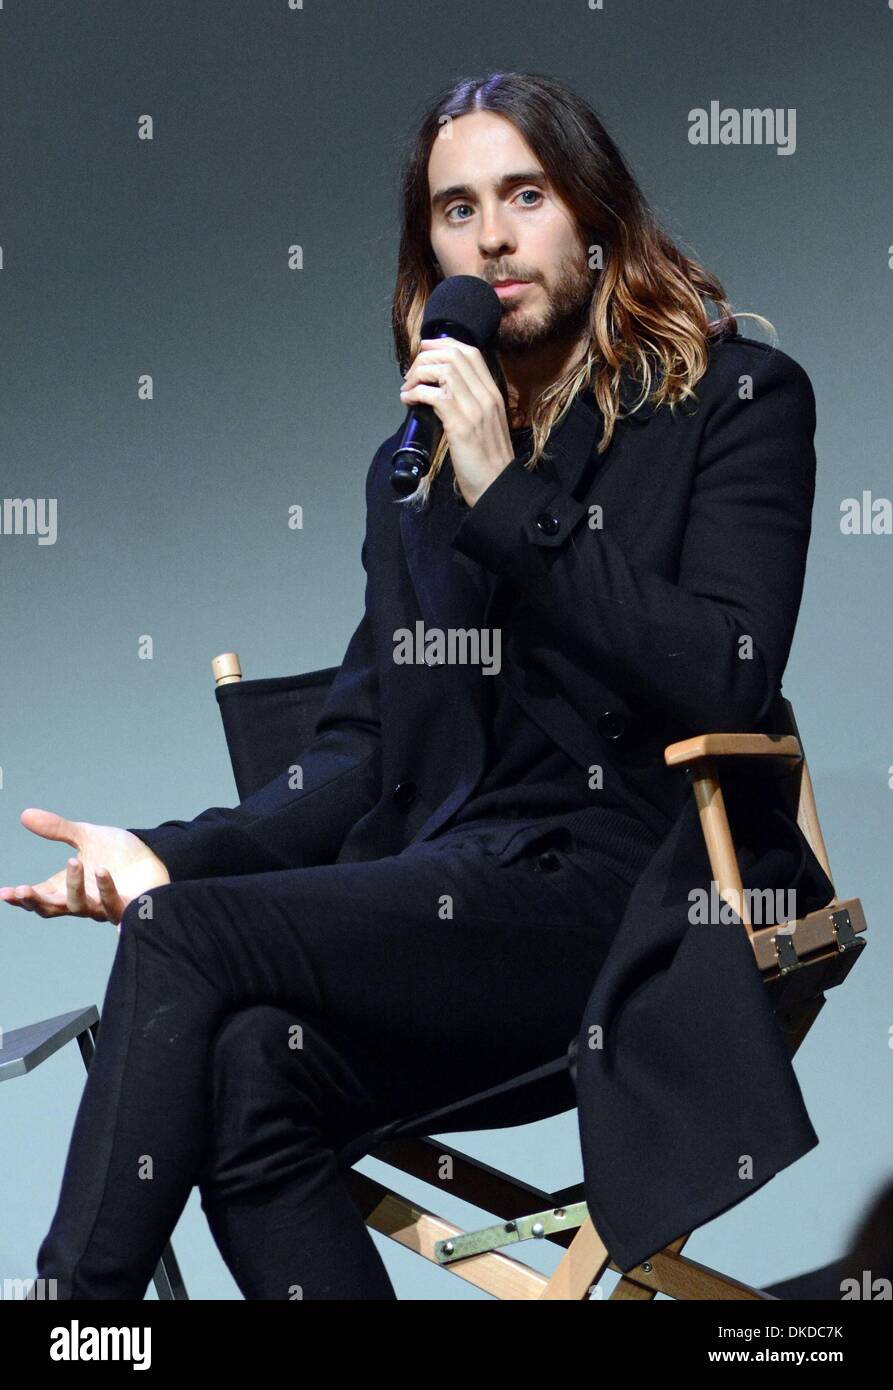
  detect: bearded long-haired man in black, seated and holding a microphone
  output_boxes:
[1,74,815,1298]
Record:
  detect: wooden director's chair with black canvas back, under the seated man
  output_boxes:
[200,652,865,1301]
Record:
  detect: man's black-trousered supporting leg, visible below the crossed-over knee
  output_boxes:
[198,1004,396,1298]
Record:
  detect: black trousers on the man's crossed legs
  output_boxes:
[31,824,634,1298]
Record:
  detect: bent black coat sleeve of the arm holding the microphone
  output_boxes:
[453,350,815,733]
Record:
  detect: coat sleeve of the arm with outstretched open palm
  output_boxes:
[127,450,381,883]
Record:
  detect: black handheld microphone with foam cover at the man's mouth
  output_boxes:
[391,275,502,498]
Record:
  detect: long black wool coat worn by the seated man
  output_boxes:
[128,338,833,1269]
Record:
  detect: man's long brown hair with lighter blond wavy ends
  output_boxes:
[391,72,775,505]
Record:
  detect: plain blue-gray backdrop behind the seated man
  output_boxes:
[0,0,893,1300]
